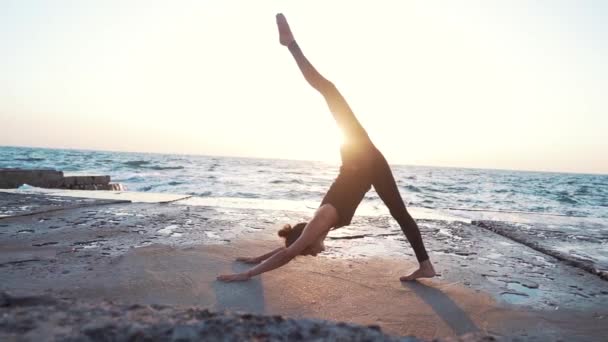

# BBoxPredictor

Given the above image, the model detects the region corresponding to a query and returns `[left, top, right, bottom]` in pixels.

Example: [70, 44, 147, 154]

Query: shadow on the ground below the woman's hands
[213, 262, 266, 314]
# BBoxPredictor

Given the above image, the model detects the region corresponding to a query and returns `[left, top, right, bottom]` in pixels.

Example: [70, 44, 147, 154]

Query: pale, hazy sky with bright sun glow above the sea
[0, 0, 608, 173]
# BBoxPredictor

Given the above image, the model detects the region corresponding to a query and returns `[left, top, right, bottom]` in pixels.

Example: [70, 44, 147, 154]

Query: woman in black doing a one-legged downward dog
[218, 14, 435, 281]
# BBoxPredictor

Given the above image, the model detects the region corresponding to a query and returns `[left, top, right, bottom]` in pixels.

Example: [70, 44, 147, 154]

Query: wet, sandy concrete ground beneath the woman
[0, 191, 608, 340]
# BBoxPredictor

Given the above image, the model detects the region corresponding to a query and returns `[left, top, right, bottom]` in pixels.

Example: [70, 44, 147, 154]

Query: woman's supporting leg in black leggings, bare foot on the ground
[372, 152, 435, 280]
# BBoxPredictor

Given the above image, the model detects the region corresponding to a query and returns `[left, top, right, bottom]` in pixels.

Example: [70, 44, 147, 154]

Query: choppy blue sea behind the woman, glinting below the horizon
[0, 146, 608, 270]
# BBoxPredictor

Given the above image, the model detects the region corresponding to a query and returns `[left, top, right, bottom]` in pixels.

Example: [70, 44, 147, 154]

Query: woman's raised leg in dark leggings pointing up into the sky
[277, 14, 369, 140]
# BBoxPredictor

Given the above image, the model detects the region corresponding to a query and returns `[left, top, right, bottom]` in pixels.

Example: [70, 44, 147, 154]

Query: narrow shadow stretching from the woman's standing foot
[402, 281, 479, 336]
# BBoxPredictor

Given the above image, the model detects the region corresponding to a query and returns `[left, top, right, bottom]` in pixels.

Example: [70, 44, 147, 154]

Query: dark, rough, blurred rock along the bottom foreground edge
[0, 293, 458, 342]
